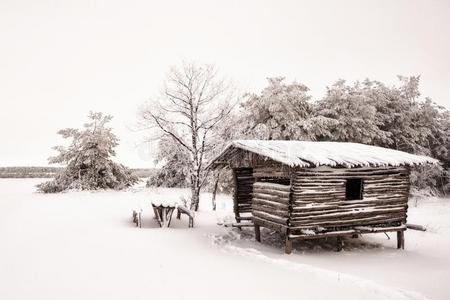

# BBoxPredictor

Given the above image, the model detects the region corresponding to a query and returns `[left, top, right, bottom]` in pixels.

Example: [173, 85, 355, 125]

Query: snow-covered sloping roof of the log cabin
[210, 140, 439, 168]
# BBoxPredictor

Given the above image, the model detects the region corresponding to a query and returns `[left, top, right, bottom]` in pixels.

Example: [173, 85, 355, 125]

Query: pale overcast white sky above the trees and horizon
[0, 0, 450, 167]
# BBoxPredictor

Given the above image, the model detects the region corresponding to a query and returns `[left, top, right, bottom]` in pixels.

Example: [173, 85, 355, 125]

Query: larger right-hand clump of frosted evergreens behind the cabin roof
[315, 76, 450, 192]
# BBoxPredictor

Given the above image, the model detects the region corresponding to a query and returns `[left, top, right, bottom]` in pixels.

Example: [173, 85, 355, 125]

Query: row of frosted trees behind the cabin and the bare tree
[149, 76, 450, 194]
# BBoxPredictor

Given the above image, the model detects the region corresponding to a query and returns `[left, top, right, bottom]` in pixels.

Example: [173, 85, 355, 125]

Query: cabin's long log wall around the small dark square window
[289, 167, 409, 234]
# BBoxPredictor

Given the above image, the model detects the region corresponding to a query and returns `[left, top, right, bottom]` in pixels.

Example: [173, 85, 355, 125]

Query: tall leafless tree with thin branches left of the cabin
[141, 63, 234, 210]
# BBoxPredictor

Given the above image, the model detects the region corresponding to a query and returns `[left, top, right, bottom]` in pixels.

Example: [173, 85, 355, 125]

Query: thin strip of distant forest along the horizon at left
[0, 167, 156, 178]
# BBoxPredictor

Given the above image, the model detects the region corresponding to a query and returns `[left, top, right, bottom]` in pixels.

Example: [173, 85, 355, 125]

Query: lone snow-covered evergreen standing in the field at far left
[38, 112, 139, 193]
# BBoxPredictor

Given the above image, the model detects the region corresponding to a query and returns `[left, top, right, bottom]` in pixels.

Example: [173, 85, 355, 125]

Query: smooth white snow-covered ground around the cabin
[0, 179, 450, 300]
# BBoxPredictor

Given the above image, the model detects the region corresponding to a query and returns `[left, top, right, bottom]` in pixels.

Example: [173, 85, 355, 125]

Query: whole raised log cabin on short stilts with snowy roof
[210, 140, 437, 253]
